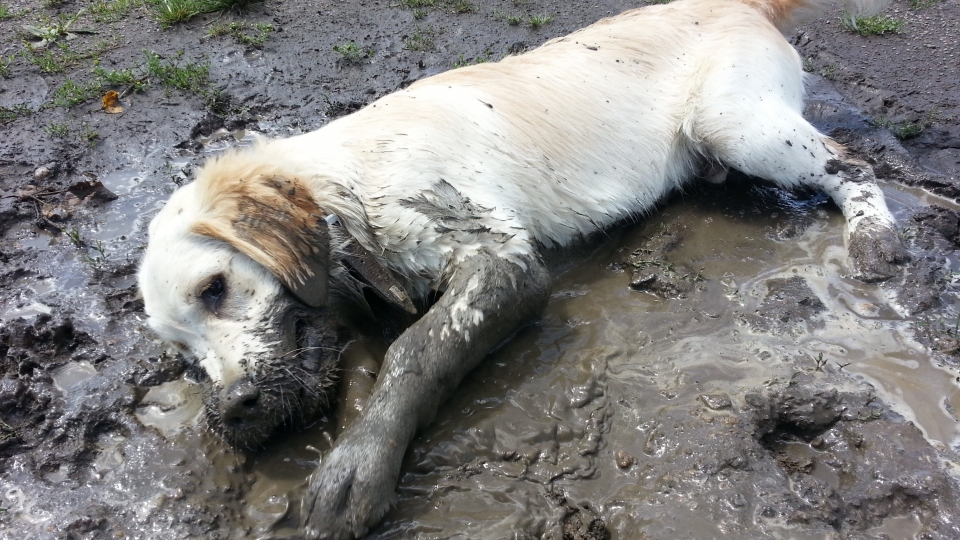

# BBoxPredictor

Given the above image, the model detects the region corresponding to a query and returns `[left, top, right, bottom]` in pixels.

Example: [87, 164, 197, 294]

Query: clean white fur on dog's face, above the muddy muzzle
[140, 200, 289, 386]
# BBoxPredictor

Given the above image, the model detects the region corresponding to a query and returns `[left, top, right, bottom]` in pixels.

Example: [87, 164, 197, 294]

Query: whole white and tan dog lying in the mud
[139, 0, 907, 539]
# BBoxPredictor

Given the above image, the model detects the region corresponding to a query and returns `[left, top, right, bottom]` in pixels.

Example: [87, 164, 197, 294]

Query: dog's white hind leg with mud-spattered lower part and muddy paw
[698, 107, 908, 282]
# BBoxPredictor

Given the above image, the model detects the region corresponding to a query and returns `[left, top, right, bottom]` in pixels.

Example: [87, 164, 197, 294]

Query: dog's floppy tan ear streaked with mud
[191, 176, 330, 307]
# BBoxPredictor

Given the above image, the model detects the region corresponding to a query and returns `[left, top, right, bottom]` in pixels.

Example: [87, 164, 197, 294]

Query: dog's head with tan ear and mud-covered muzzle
[138, 155, 338, 447]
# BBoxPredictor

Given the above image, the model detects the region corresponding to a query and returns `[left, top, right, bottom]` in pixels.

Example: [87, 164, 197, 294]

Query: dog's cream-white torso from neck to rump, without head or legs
[255, 0, 883, 292]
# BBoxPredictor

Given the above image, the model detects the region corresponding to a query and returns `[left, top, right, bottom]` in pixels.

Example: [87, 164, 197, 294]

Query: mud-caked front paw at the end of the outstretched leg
[301, 439, 403, 540]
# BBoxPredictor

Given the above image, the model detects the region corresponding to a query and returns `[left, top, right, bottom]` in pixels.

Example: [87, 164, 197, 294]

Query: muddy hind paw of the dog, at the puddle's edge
[847, 225, 910, 283]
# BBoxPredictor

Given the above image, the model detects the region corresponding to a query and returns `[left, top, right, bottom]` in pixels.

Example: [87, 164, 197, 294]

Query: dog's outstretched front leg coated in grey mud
[302, 251, 550, 539]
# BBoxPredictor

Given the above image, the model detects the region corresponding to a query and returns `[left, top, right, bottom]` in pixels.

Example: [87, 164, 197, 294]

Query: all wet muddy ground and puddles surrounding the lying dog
[0, 0, 960, 540]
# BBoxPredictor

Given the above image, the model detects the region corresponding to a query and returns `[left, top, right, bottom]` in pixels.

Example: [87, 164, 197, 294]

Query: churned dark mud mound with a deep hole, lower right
[745, 377, 957, 538]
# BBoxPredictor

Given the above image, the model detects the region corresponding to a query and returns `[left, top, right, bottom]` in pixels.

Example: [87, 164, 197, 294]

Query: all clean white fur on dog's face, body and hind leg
[140, 0, 893, 390]
